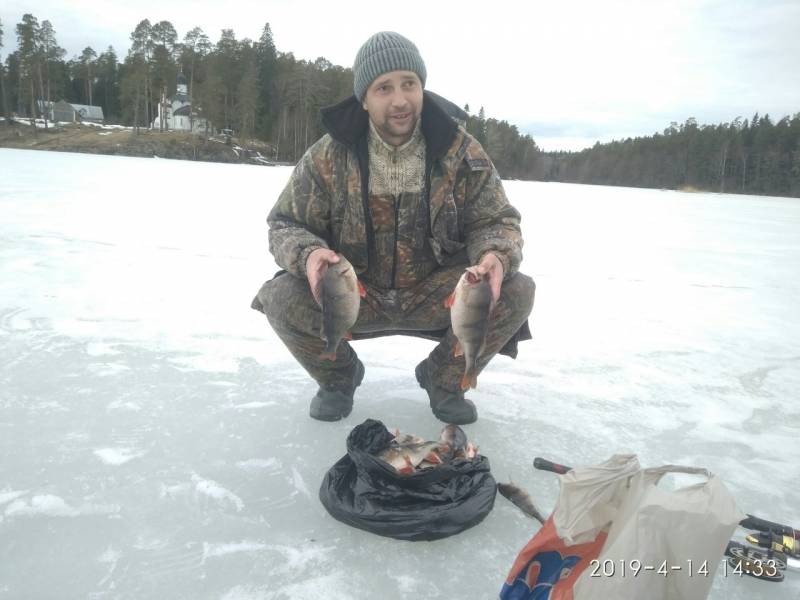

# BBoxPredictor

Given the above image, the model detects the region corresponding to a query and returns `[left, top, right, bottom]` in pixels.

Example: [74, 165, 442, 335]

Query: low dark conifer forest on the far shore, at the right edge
[535, 113, 800, 197]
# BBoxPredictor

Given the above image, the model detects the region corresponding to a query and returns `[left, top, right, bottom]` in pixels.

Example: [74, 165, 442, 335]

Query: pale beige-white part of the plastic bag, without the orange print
[553, 455, 744, 600]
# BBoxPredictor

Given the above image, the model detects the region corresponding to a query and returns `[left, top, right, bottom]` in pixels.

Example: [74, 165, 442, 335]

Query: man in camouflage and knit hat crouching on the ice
[253, 31, 535, 424]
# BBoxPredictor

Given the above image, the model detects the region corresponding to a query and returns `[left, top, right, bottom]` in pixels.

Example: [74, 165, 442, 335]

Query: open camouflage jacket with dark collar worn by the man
[267, 93, 522, 284]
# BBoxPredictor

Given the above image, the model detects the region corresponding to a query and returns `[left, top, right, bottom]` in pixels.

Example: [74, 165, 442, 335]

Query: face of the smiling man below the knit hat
[363, 71, 422, 146]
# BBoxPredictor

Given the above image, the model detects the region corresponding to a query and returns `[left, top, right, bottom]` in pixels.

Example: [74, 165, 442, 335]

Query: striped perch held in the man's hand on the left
[318, 254, 365, 360]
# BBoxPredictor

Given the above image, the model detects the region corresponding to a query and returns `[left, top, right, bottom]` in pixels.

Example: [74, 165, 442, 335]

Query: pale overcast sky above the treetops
[0, 0, 800, 150]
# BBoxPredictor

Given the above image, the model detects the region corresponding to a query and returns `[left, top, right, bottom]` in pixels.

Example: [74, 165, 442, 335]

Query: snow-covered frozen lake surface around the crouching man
[0, 149, 800, 600]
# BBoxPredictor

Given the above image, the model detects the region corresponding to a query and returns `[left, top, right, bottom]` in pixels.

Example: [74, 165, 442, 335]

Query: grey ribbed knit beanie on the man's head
[353, 31, 426, 101]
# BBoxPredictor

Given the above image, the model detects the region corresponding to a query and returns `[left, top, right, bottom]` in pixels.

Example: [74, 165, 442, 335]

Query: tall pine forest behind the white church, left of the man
[0, 14, 353, 160]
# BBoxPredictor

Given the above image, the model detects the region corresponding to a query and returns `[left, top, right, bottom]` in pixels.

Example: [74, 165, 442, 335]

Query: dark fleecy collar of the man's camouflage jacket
[320, 92, 458, 158]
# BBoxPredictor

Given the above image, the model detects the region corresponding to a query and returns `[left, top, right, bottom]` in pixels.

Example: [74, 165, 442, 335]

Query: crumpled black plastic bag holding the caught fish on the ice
[319, 419, 497, 541]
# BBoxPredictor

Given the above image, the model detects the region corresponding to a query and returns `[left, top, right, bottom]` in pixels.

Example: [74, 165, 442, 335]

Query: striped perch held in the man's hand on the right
[445, 267, 494, 390]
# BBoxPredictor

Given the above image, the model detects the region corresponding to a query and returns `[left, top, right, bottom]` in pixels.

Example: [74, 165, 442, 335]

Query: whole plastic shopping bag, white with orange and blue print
[500, 454, 744, 600]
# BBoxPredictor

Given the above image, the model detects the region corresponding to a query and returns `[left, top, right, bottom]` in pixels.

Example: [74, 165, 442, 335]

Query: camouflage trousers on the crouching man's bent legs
[253, 265, 536, 391]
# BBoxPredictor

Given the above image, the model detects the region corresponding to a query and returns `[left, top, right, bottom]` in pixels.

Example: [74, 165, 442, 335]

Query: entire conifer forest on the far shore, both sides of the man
[0, 14, 800, 196]
